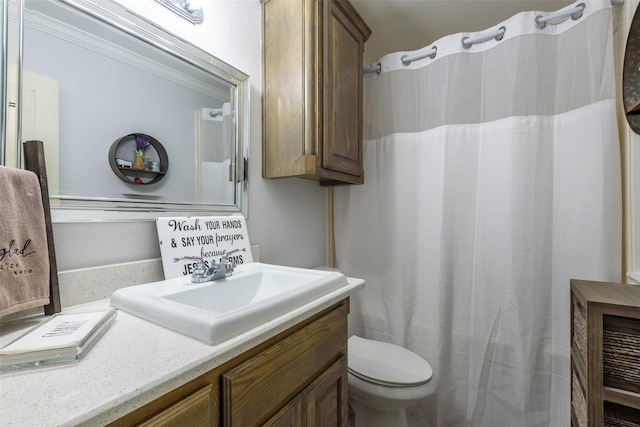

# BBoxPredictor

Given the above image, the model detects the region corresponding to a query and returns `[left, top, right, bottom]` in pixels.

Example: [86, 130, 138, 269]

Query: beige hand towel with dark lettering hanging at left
[0, 166, 49, 316]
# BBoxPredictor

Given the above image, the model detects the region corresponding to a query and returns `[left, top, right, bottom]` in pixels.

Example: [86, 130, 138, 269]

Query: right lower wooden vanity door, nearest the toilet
[302, 356, 349, 427]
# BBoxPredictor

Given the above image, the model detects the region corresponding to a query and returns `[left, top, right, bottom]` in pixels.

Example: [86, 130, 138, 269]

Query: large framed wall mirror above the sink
[5, 0, 249, 220]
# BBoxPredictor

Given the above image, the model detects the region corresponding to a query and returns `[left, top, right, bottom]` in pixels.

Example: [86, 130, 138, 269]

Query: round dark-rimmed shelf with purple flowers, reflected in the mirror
[109, 133, 169, 185]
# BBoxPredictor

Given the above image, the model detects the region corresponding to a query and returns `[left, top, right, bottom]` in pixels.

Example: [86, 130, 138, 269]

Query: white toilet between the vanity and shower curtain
[348, 335, 435, 427]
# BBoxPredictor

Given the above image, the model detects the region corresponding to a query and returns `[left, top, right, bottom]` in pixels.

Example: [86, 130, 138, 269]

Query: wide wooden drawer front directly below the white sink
[222, 304, 347, 426]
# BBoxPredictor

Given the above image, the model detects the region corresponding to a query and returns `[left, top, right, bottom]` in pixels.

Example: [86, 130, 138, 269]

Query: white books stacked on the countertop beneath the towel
[0, 308, 117, 371]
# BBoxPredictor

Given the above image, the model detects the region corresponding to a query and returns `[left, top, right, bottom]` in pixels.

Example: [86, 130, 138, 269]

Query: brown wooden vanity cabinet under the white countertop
[112, 300, 348, 427]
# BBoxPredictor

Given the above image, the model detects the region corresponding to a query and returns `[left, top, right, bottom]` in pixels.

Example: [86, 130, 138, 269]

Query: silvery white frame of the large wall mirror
[2, 0, 250, 222]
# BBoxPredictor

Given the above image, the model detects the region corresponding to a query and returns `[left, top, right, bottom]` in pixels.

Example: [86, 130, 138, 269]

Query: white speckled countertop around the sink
[0, 278, 364, 427]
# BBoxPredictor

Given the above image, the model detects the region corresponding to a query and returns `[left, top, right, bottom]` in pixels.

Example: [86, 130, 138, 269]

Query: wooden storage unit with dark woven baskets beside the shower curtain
[571, 280, 640, 427]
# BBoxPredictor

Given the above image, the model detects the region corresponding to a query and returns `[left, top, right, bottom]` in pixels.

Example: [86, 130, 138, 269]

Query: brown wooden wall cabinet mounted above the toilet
[262, 0, 371, 185]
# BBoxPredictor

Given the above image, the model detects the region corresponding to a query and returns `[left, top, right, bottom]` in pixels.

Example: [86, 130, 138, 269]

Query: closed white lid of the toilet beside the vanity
[348, 335, 433, 387]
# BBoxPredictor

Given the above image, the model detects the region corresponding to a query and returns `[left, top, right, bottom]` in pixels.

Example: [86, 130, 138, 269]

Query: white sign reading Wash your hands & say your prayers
[156, 215, 253, 279]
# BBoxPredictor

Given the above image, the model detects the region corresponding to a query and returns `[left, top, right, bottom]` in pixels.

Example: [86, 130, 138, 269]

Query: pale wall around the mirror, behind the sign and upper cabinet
[54, 0, 326, 271]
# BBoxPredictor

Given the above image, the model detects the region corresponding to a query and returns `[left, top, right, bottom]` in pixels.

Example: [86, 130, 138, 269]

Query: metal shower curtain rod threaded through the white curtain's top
[363, 0, 624, 75]
